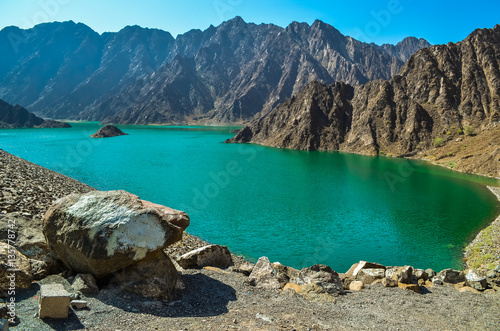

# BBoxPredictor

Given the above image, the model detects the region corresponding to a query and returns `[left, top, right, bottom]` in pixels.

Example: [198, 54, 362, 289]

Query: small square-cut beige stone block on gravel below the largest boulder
[38, 284, 70, 318]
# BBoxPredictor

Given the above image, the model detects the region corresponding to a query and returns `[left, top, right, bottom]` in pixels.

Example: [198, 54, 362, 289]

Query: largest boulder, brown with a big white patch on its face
[43, 191, 189, 278]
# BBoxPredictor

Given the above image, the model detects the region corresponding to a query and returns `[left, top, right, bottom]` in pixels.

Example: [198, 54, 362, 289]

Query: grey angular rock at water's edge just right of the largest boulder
[177, 245, 233, 269]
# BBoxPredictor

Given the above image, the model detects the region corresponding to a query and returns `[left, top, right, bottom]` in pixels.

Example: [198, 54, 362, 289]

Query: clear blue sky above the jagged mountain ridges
[0, 0, 500, 44]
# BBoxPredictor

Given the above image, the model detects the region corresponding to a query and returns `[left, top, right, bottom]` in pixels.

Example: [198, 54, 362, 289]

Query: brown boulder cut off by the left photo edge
[0, 242, 33, 292]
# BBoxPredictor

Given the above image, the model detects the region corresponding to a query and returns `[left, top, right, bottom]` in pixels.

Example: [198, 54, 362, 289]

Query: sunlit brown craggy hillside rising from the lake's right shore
[231, 25, 500, 176]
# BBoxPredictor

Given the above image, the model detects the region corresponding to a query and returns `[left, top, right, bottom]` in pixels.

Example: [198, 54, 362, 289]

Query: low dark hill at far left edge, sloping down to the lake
[0, 99, 70, 129]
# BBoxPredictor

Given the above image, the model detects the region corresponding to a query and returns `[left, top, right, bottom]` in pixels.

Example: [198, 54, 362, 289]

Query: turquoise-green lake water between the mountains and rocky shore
[0, 123, 498, 272]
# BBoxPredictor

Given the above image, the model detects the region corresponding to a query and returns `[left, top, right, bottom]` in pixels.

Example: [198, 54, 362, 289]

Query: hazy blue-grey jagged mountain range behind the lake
[0, 17, 430, 124]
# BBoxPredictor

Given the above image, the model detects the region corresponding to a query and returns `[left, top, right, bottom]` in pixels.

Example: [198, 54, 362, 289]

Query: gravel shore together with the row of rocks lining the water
[0, 150, 500, 330]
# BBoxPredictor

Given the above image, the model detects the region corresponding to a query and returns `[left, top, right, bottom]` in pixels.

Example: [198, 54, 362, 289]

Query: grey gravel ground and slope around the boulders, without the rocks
[0, 150, 500, 330]
